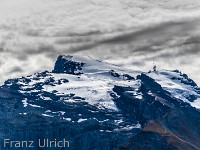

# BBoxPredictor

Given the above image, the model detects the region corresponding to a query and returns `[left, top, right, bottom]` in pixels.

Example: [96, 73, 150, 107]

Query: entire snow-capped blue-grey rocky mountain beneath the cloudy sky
[0, 56, 200, 150]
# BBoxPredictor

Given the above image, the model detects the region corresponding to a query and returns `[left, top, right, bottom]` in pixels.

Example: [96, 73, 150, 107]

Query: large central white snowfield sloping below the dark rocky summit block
[18, 56, 141, 111]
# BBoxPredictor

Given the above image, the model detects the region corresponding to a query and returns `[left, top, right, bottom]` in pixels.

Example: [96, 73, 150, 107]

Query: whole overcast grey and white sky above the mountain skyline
[0, 0, 200, 85]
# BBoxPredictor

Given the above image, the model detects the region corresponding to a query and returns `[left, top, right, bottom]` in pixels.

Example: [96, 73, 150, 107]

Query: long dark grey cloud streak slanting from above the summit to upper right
[63, 20, 199, 52]
